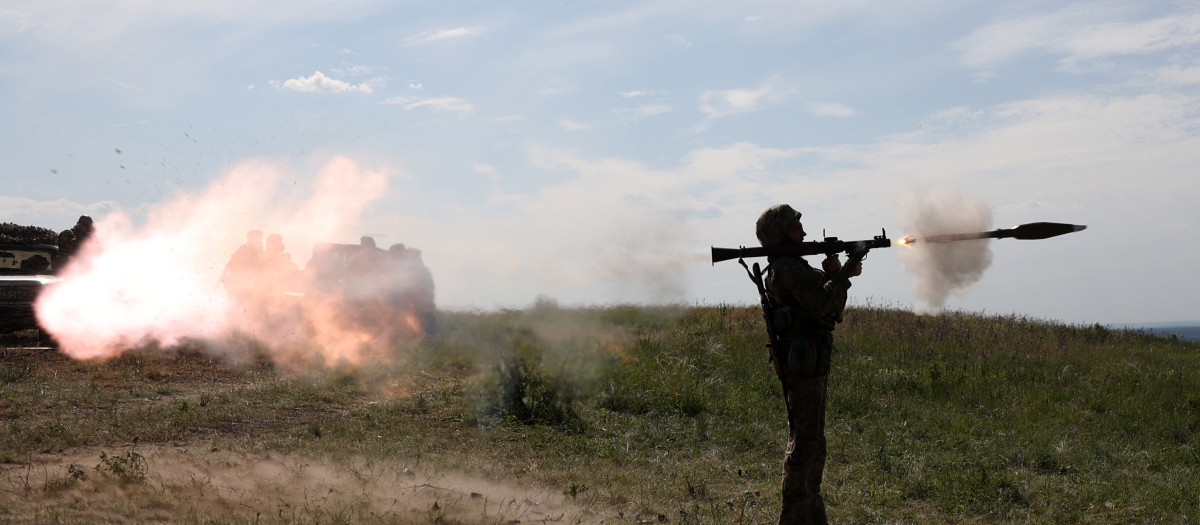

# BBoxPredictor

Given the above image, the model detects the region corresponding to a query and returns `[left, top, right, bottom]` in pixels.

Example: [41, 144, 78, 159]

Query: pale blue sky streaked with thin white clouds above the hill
[0, 0, 1200, 325]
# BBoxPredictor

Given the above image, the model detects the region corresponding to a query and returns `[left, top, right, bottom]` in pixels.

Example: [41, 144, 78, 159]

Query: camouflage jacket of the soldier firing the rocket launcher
[766, 257, 850, 338]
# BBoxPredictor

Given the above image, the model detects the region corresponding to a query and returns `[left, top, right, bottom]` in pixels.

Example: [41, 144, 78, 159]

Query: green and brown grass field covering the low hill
[0, 304, 1200, 524]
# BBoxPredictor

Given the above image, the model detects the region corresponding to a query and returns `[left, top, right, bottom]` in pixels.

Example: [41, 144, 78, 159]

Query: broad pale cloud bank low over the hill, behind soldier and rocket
[424, 91, 1200, 322]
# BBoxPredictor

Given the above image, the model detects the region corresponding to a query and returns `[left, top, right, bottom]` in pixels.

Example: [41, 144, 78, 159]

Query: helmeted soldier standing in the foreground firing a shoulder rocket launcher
[756, 204, 863, 525]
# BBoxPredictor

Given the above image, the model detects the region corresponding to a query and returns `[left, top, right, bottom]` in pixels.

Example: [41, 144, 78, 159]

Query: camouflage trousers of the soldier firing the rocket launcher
[779, 334, 833, 525]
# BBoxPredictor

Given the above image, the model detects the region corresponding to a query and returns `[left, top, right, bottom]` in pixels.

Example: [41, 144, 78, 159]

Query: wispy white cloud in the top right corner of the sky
[953, 4, 1200, 70]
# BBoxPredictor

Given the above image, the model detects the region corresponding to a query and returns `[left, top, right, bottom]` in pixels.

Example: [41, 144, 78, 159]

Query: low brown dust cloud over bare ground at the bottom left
[0, 446, 600, 524]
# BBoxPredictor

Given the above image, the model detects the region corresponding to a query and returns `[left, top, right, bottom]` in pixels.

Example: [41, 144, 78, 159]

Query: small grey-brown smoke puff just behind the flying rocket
[899, 187, 991, 314]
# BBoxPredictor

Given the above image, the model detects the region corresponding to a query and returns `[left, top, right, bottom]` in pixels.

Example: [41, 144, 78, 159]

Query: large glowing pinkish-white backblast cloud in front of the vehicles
[36, 157, 386, 362]
